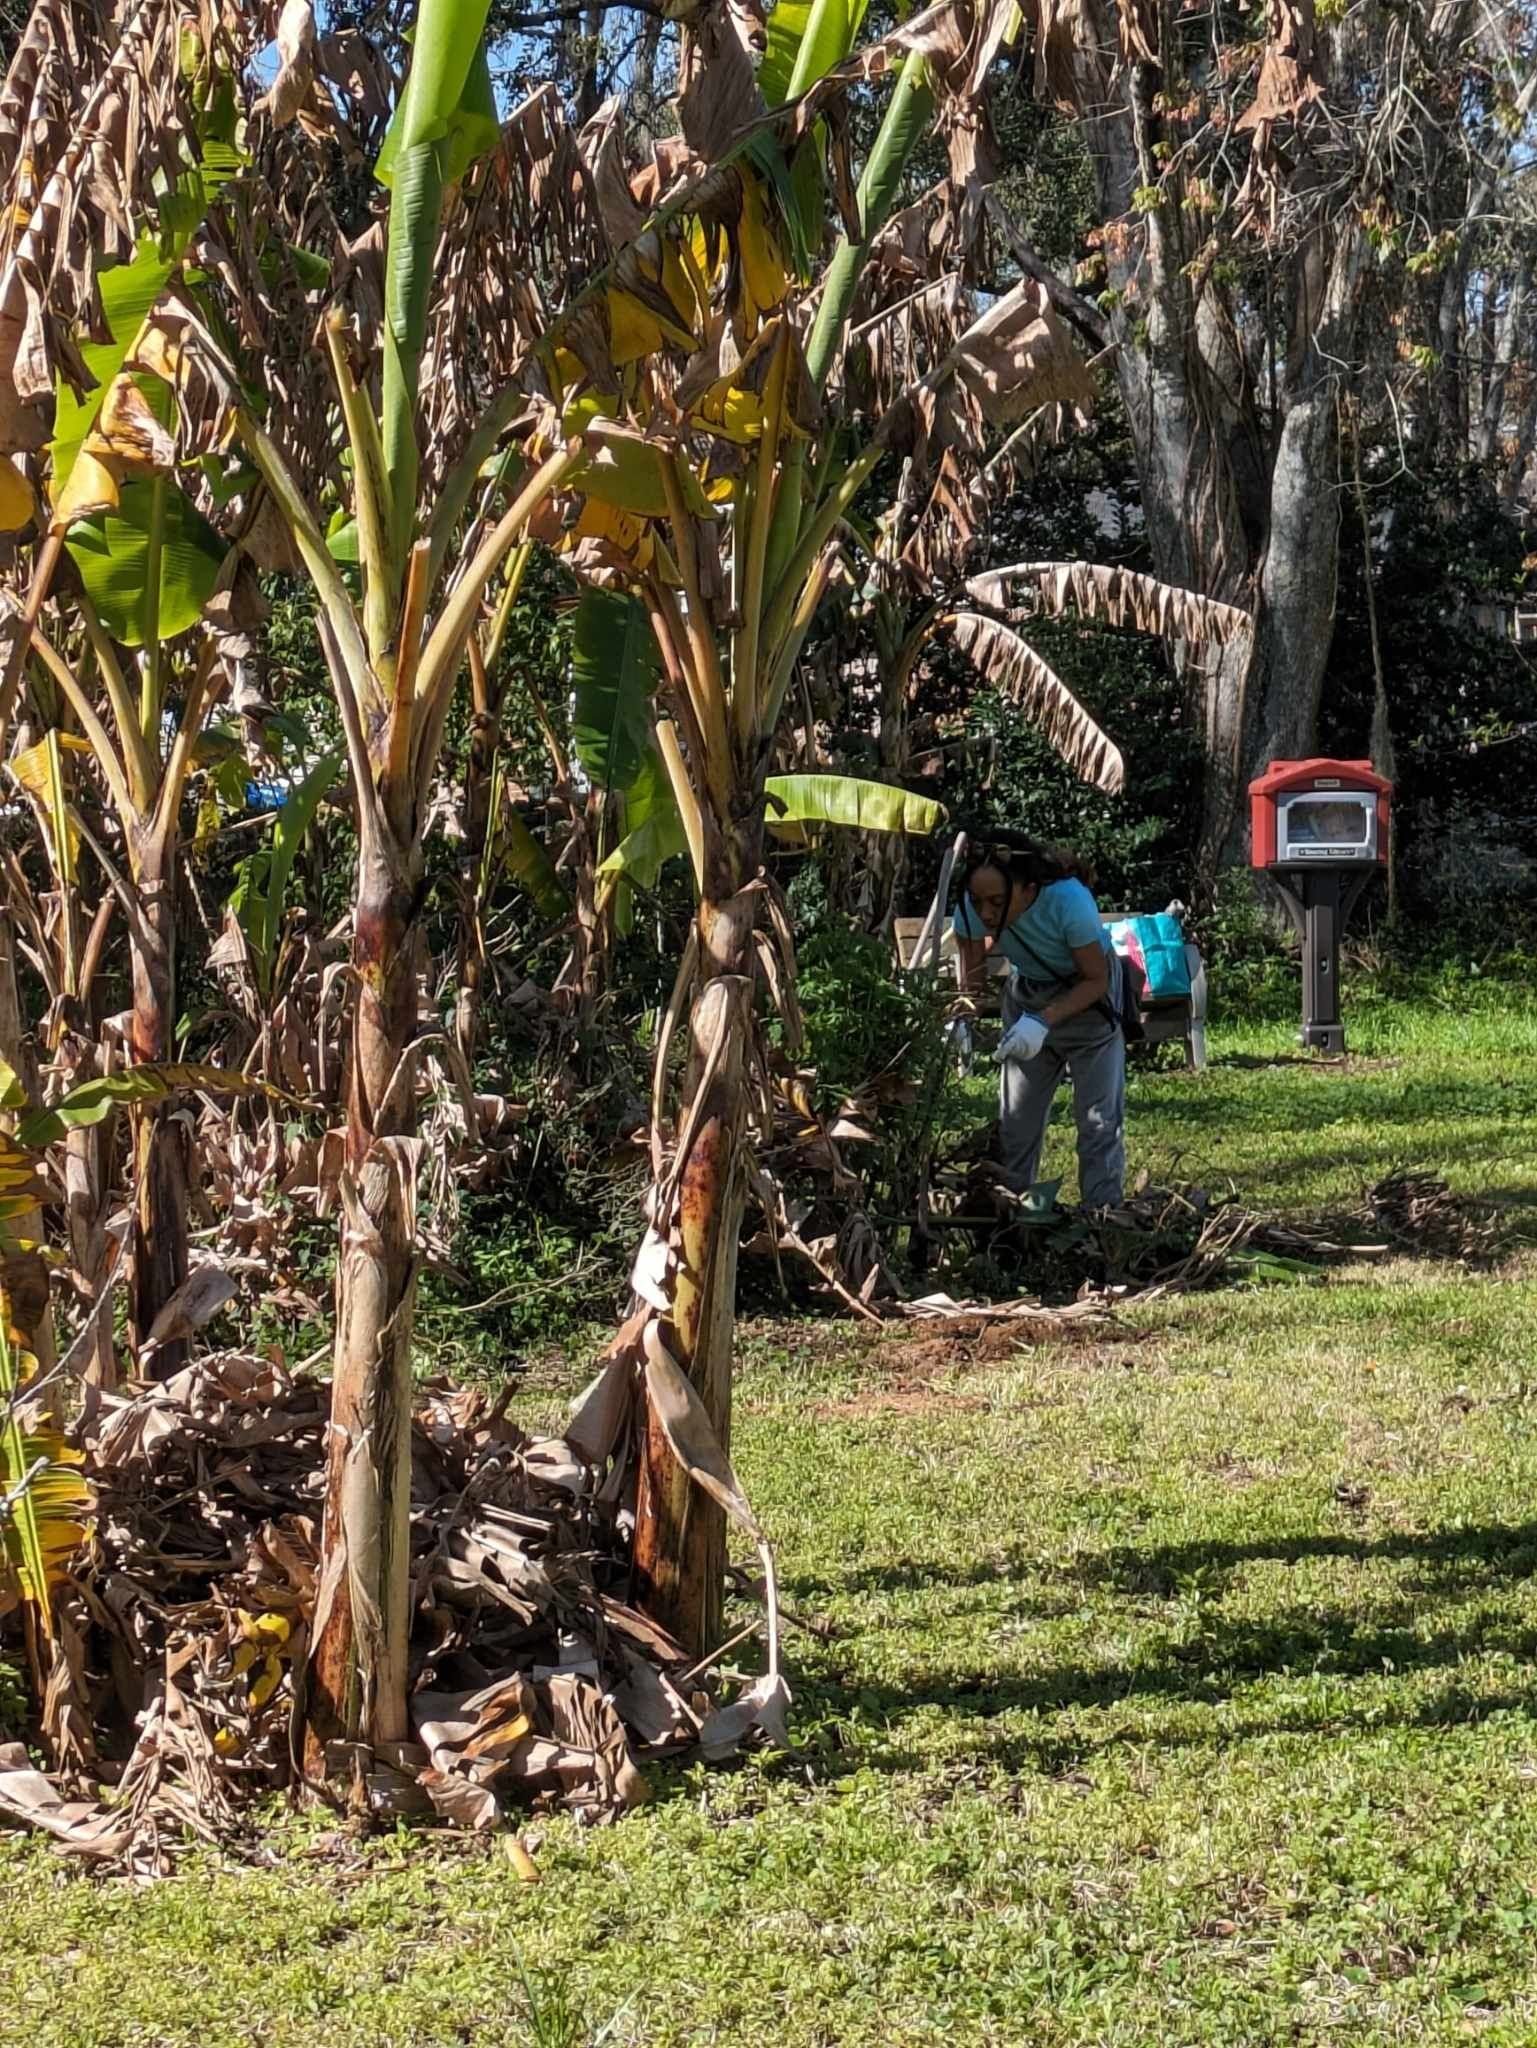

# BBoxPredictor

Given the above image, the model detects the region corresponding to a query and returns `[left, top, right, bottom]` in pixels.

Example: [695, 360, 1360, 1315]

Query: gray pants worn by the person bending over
[998, 961, 1125, 1208]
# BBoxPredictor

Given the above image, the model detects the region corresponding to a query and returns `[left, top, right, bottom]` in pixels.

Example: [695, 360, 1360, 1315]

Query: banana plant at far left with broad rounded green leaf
[0, 35, 259, 1374]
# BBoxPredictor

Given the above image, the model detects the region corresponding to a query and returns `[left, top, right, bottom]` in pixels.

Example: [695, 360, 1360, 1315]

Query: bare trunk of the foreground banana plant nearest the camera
[305, 817, 422, 1778]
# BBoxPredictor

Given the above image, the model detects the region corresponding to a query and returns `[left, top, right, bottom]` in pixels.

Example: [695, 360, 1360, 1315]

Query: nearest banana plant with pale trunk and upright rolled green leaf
[227, 0, 582, 1778]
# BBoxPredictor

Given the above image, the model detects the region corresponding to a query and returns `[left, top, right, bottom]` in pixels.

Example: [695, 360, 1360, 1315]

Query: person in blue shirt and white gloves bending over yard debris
[955, 842, 1125, 1208]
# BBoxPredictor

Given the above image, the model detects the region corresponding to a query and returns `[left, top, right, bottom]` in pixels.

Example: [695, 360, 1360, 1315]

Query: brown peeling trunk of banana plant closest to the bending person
[633, 842, 758, 1657]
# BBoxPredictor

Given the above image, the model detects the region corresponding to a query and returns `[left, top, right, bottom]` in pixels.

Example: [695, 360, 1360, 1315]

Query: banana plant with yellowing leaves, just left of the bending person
[483, 0, 1123, 1653]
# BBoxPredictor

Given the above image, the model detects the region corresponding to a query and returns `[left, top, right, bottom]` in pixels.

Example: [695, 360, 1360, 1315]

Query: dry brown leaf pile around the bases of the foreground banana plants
[0, 1352, 770, 1876]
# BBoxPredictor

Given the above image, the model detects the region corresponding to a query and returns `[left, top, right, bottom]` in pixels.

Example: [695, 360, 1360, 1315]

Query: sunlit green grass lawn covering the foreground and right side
[0, 991, 1537, 2048]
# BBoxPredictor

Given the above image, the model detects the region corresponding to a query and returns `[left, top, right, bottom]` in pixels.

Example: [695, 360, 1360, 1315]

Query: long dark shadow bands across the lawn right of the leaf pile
[770, 1522, 1537, 1776]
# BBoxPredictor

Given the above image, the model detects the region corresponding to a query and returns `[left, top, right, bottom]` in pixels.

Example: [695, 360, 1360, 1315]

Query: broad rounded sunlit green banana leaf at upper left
[68, 483, 225, 647]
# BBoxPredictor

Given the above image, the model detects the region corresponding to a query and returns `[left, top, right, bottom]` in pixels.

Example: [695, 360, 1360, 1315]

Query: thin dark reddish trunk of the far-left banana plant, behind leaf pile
[129, 834, 191, 1380]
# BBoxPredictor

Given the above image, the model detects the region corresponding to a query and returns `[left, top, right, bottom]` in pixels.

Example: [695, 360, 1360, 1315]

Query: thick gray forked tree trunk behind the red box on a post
[1072, 0, 1365, 883]
